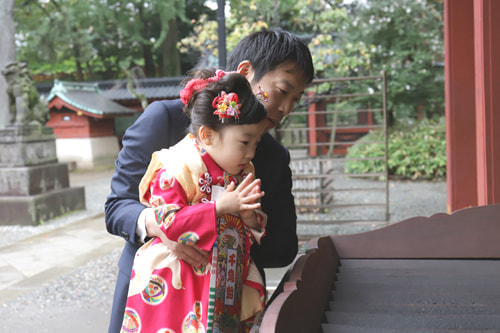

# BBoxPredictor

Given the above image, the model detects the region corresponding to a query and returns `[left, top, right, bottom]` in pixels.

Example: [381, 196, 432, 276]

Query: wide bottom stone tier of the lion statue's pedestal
[0, 187, 86, 225]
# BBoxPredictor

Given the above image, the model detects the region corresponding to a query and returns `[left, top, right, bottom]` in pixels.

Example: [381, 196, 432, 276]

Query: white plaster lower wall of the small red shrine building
[56, 136, 120, 169]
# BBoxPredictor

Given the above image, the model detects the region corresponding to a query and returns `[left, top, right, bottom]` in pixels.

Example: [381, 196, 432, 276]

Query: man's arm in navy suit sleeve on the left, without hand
[104, 100, 189, 245]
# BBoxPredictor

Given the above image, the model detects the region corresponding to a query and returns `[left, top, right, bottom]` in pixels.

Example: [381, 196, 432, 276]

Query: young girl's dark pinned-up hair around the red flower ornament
[184, 68, 267, 134]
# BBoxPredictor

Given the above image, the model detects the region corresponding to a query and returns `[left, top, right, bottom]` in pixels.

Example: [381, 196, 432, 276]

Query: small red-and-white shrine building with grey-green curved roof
[46, 80, 136, 169]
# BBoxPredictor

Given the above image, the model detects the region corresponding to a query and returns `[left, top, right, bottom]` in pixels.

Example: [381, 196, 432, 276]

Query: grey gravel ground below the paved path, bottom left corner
[0, 249, 121, 333]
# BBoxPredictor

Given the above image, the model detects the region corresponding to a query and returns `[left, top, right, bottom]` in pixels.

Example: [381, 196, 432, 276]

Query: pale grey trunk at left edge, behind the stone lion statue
[0, 0, 16, 128]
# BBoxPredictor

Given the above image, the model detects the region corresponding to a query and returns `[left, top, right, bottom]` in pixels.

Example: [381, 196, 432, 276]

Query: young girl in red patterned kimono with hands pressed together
[122, 70, 266, 333]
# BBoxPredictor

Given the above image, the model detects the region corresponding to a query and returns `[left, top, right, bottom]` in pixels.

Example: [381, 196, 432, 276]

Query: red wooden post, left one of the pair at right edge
[444, 0, 477, 212]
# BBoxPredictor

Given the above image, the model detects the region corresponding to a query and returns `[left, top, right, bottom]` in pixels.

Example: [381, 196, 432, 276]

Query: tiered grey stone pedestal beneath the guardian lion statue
[0, 124, 85, 225]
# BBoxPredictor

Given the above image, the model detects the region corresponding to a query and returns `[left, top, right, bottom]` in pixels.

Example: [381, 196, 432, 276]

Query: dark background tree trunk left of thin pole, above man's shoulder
[160, 18, 181, 76]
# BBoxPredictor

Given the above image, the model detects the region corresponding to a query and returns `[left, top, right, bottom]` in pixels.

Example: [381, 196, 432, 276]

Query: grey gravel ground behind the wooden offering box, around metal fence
[297, 178, 447, 239]
